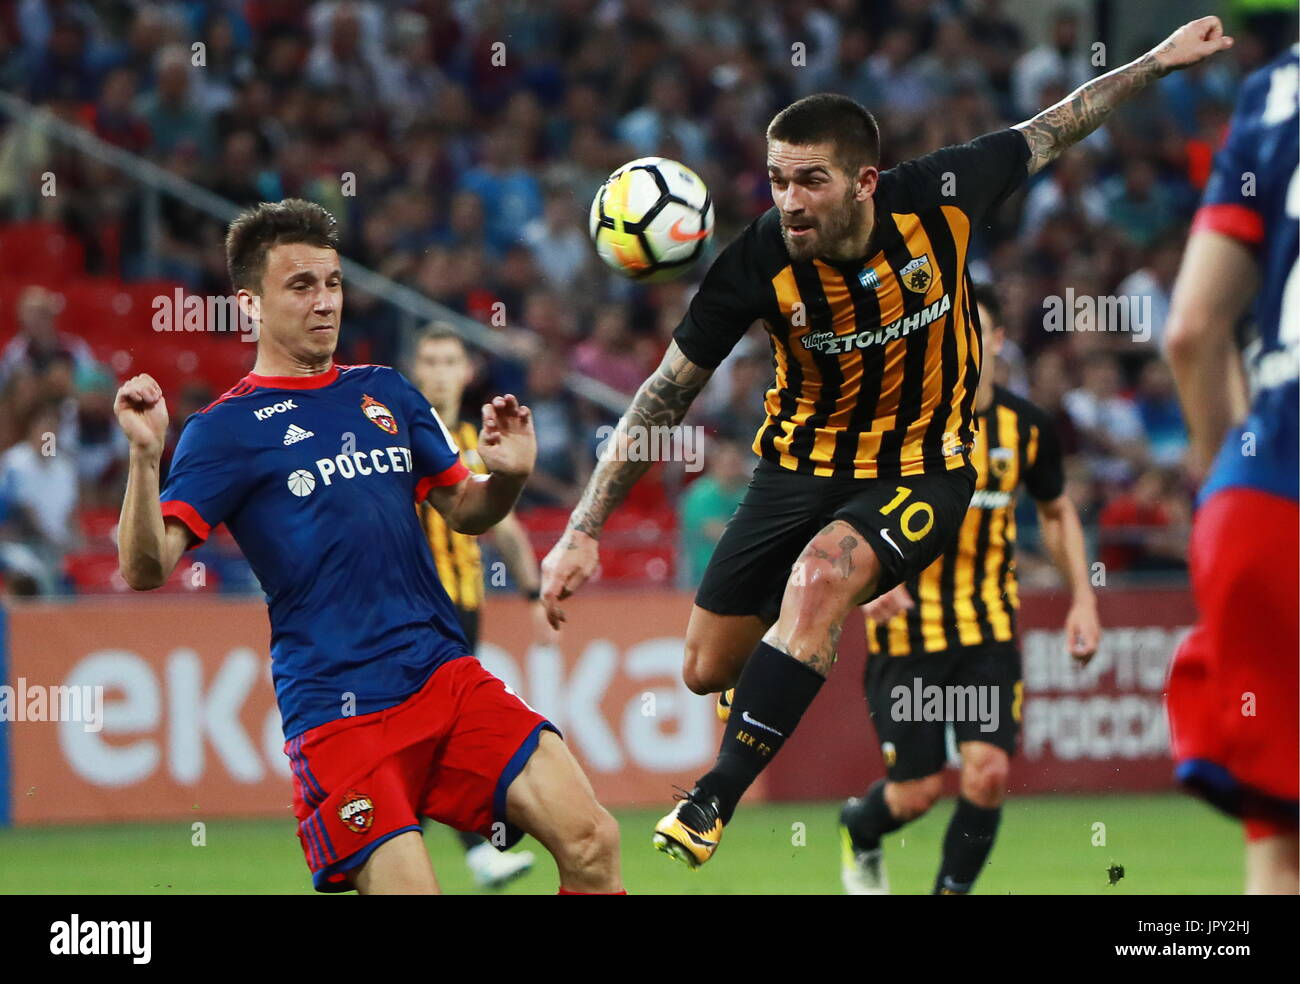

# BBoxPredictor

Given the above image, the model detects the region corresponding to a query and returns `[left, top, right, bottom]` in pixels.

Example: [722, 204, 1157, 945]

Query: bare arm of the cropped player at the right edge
[1165, 231, 1260, 476]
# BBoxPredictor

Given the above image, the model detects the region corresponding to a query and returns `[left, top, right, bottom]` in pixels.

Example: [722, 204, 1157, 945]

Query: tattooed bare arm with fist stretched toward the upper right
[1014, 17, 1232, 174]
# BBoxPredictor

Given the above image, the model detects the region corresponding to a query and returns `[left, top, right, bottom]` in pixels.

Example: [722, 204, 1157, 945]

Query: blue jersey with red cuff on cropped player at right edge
[1192, 45, 1300, 502]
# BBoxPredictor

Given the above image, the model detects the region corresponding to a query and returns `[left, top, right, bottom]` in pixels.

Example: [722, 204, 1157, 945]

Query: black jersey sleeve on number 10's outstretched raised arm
[888, 129, 1030, 226]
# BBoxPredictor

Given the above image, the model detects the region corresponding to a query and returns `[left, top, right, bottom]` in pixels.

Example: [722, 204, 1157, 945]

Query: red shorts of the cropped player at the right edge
[1166, 489, 1300, 827]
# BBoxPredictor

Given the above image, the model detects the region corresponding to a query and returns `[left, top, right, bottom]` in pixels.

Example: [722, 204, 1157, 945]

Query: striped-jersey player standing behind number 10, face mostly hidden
[840, 286, 1100, 896]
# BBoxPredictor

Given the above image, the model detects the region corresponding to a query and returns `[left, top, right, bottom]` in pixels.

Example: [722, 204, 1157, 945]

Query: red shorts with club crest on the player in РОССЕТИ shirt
[285, 656, 559, 892]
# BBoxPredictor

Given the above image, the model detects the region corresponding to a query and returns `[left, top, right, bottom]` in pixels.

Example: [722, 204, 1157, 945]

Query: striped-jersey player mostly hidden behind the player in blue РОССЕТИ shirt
[411, 324, 558, 888]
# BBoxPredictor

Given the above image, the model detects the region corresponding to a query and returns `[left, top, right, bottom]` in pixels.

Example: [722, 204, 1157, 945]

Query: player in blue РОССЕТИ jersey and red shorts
[116, 200, 623, 894]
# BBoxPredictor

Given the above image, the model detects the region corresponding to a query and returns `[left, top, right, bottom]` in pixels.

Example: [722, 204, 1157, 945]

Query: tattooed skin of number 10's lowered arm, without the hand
[568, 342, 712, 537]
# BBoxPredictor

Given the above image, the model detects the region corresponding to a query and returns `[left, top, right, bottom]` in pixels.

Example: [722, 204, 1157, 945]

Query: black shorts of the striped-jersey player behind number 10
[866, 642, 1024, 783]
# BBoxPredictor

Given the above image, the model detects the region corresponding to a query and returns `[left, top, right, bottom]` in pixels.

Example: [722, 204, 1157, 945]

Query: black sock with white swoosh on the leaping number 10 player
[696, 642, 826, 823]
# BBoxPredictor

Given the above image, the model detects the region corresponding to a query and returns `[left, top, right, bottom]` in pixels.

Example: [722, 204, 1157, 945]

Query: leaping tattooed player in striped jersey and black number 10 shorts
[542, 17, 1231, 866]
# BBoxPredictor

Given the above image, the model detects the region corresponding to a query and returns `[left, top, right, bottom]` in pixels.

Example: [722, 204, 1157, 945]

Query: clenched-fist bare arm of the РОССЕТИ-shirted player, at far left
[113, 374, 190, 591]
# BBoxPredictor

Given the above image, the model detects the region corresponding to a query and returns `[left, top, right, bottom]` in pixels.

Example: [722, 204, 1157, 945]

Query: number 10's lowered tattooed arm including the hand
[542, 342, 714, 628]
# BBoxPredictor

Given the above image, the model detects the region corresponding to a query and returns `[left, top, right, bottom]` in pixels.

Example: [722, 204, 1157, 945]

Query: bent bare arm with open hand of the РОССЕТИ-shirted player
[429, 394, 537, 537]
